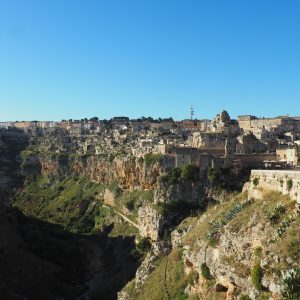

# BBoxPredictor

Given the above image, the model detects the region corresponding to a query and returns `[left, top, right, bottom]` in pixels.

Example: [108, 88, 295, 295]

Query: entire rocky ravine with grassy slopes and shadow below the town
[0, 127, 300, 300]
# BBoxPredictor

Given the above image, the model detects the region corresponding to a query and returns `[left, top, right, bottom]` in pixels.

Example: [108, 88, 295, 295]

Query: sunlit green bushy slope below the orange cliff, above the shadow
[13, 177, 104, 233]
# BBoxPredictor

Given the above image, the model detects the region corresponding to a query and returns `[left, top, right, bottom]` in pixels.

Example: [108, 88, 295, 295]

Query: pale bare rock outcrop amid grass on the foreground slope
[180, 197, 299, 300]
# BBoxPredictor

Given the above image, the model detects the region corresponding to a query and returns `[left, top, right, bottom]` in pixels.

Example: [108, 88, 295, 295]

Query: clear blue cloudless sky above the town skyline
[0, 0, 300, 120]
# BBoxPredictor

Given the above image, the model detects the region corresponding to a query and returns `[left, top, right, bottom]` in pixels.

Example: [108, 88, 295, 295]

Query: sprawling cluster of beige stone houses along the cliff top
[0, 111, 300, 171]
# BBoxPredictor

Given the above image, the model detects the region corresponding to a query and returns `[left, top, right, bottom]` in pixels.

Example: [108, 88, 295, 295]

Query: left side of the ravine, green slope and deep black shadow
[0, 130, 141, 299]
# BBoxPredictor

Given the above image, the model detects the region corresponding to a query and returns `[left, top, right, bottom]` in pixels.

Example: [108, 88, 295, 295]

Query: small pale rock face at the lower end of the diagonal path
[138, 205, 165, 241]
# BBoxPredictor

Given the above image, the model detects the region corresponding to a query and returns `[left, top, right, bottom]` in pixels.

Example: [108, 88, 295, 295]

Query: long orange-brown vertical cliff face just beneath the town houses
[27, 154, 164, 190]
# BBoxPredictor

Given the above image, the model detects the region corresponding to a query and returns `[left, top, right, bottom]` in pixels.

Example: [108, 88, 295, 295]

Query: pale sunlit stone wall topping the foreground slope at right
[244, 170, 300, 203]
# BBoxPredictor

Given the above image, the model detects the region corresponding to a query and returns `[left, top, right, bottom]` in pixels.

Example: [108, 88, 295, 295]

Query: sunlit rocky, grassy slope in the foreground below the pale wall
[119, 192, 300, 300]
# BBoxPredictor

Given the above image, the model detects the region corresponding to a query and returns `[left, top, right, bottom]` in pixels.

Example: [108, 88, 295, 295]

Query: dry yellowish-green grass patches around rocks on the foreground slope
[181, 192, 300, 292]
